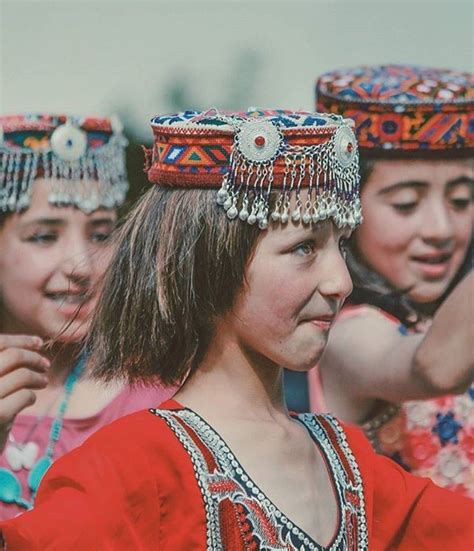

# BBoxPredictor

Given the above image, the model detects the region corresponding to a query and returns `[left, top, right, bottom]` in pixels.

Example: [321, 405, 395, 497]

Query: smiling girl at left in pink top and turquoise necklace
[0, 115, 172, 519]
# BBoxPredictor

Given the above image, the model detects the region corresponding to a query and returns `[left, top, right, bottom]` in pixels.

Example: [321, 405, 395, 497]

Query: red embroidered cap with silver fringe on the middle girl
[148, 109, 361, 229]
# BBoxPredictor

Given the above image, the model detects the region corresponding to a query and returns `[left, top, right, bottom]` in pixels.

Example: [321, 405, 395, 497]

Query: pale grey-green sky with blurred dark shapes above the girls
[0, 0, 474, 142]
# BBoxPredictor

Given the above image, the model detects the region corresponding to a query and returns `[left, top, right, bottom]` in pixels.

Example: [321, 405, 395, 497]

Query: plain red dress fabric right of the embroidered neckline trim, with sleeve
[344, 420, 474, 551]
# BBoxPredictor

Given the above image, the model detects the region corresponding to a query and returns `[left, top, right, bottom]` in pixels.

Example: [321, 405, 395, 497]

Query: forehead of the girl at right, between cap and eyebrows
[363, 158, 474, 191]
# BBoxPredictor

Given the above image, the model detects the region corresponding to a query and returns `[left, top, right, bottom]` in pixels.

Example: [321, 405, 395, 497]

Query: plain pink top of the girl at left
[0, 386, 175, 520]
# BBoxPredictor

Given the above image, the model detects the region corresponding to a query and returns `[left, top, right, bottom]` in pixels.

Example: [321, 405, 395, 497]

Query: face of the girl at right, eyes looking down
[355, 160, 474, 303]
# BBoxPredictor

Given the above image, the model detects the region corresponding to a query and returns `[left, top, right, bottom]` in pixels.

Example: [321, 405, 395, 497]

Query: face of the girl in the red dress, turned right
[226, 221, 352, 371]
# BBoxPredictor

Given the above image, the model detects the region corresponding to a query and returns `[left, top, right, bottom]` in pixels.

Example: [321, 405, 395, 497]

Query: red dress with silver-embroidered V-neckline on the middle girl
[0, 400, 474, 551]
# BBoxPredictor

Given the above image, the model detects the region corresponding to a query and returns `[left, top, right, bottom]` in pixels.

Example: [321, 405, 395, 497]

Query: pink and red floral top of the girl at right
[308, 305, 474, 498]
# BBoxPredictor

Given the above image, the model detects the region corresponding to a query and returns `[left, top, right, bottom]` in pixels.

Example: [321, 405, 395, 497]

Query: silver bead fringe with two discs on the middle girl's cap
[217, 121, 362, 229]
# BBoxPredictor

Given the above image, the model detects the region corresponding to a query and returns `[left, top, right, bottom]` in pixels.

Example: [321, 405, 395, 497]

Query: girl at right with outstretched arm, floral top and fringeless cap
[309, 66, 474, 497]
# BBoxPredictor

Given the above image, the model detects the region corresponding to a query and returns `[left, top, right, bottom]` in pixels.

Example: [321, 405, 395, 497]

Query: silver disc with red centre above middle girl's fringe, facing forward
[236, 120, 283, 163]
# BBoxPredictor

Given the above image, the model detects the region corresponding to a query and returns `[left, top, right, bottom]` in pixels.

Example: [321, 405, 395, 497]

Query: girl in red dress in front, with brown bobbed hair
[1, 111, 470, 551]
